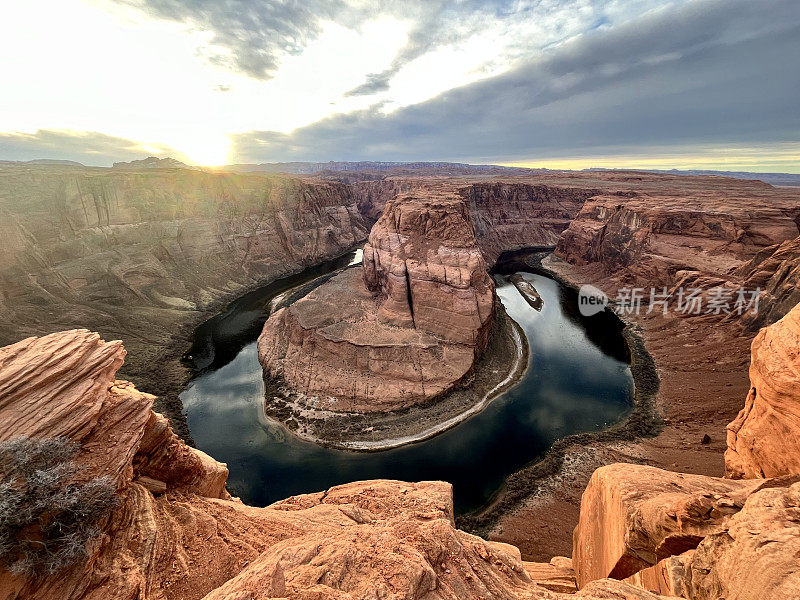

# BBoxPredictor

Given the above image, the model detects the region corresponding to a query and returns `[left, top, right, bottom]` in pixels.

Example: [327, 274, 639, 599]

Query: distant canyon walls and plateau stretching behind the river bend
[0, 159, 800, 434]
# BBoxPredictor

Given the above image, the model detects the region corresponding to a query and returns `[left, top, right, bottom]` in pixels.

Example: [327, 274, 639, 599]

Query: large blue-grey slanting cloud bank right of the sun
[234, 0, 800, 162]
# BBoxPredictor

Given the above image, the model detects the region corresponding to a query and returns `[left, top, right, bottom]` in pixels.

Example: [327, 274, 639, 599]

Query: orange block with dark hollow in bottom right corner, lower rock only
[573, 464, 800, 600]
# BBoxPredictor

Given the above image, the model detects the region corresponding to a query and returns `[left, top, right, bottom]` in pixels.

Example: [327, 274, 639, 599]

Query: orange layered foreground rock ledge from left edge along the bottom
[0, 330, 676, 600]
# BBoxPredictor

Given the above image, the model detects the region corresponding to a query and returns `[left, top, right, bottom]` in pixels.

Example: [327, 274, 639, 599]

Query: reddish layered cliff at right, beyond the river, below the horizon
[556, 174, 800, 287]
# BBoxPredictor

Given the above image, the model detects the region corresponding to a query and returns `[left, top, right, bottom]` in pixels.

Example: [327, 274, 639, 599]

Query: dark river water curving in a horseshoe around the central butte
[181, 254, 633, 513]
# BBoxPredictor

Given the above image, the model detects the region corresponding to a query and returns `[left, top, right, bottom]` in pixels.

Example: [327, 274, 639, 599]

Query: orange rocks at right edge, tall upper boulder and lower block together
[572, 305, 800, 600]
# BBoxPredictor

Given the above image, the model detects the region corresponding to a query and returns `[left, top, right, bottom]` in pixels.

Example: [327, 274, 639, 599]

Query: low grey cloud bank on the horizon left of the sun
[0, 129, 180, 166]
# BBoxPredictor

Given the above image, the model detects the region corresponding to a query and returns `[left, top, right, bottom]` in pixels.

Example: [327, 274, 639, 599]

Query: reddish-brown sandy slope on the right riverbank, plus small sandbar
[483, 263, 755, 561]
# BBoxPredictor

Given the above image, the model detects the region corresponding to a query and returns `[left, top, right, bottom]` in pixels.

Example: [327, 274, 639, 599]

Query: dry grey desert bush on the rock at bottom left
[0, 436, 115, 575]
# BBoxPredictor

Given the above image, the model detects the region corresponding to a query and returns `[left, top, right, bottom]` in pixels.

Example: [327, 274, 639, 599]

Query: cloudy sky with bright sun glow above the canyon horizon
[0, 0, 800, 172]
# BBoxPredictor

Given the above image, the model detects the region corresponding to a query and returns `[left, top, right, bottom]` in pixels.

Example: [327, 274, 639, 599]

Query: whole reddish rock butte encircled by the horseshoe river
[258, 196, 496, 412]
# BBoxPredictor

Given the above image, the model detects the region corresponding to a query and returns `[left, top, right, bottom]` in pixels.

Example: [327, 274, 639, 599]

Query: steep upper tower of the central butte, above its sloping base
[364, 196, 495, 346]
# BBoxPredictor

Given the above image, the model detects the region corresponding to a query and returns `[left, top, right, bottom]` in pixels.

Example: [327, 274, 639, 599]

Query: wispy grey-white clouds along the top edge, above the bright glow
[116, 0, 686, 87]
